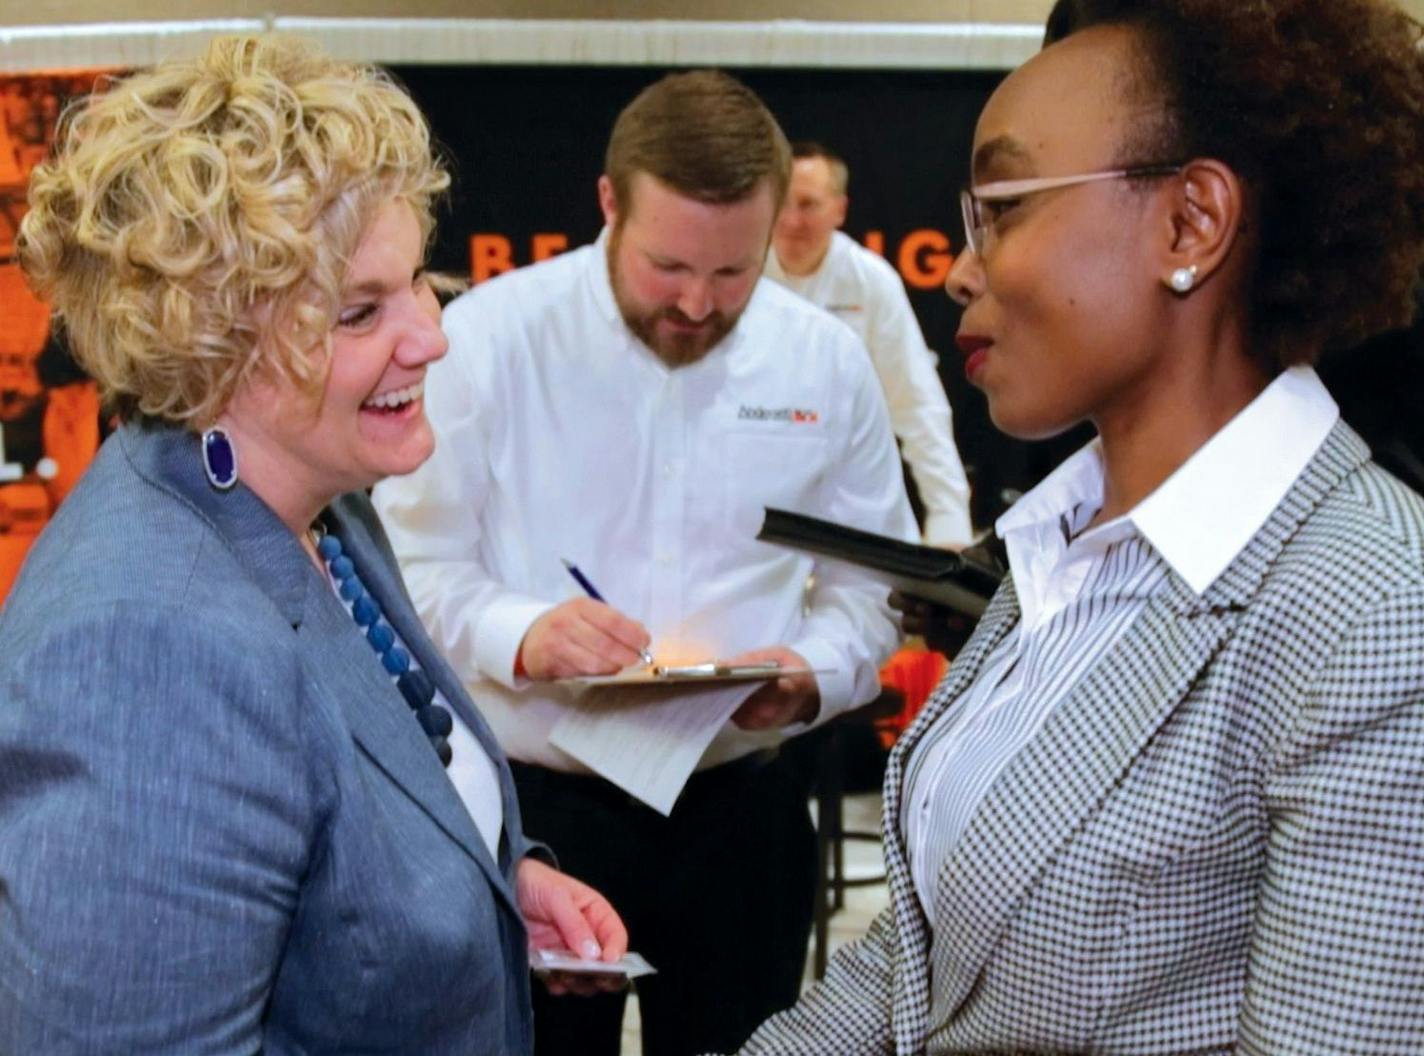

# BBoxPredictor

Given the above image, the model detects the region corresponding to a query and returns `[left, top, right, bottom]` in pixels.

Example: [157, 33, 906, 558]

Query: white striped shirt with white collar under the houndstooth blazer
[901, 367, 1340, 925]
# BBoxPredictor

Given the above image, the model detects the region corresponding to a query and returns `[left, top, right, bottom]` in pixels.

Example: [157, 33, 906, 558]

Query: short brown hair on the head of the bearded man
[604, 70, 792, 209]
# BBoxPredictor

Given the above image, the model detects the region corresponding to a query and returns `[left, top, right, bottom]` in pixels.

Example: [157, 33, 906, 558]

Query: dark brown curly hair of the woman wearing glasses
[1045, 0, 1424, 373]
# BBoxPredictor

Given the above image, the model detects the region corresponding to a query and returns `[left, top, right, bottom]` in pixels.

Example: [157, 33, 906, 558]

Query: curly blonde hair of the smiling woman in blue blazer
[19, 36, 450, 427]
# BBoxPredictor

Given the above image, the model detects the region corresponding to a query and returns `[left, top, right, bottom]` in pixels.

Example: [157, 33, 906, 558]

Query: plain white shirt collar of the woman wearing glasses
[995, 367, 1340, 593]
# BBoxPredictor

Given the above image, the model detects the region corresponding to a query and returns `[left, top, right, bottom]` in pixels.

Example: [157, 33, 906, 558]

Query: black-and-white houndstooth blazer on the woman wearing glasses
[743, 424, 1424, 1056]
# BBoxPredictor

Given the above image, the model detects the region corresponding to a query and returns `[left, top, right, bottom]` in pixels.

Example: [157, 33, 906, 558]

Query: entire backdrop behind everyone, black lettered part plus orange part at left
[0, 65, 1424, 599]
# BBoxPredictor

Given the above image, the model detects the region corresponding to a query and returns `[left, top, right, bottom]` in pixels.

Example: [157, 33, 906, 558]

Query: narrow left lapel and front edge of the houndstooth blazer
[881, 578, 1018, 1053]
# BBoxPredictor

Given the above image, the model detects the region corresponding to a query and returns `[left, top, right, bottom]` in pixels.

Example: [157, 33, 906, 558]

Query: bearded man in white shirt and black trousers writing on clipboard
[376, 71, 916, 1056]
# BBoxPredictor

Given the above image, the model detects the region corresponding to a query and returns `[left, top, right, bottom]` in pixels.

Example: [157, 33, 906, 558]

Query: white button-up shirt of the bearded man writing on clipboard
[375, 238, 914, 771]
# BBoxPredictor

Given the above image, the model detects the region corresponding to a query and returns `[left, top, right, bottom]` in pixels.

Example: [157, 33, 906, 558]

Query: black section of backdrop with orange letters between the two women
[394, 67, 1089, 525]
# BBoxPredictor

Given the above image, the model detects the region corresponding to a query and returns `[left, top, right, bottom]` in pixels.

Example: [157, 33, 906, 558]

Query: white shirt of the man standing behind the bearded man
[766, 231, 974, 547]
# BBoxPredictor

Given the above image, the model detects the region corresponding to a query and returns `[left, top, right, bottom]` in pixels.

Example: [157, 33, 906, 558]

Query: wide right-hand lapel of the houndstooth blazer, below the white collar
[917, 423, 1368, 1028]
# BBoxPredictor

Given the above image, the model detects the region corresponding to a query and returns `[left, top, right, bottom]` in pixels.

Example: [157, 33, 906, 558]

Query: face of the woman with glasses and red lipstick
[947, 27, 1172, 438]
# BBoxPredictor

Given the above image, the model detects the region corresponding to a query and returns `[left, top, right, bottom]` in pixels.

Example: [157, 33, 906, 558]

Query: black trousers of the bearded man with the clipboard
[513, 757, 816, 1056]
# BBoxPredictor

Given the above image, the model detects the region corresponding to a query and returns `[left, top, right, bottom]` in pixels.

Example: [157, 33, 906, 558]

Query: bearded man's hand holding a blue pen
[514, 598, 651, 682]
